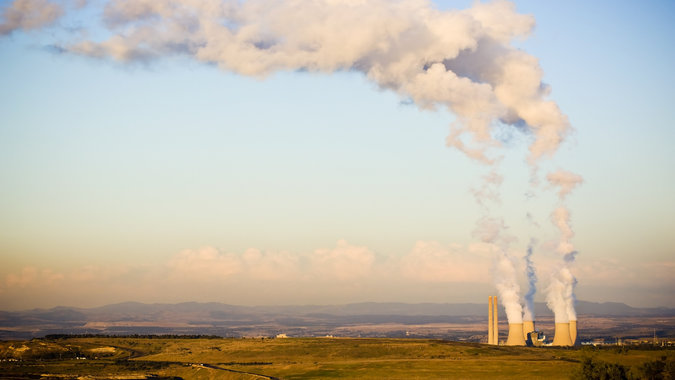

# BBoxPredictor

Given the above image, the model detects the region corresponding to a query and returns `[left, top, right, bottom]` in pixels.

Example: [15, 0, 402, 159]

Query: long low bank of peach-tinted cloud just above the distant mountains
[0, 240, 675, 308]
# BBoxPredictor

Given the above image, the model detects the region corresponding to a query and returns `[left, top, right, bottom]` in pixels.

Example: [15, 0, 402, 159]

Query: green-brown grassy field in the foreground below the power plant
[0, 337, 675, 379]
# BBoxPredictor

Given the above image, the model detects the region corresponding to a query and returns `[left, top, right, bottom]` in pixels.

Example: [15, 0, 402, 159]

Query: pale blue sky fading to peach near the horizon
[0, 0, 675, 310]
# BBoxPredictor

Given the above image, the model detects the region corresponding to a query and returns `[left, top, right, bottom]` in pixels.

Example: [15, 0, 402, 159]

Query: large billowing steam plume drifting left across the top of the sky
[1, 0, 570, 163]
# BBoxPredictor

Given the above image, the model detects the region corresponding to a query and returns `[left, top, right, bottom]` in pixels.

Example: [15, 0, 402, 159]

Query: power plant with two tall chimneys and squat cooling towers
[488, 296, 579, 347]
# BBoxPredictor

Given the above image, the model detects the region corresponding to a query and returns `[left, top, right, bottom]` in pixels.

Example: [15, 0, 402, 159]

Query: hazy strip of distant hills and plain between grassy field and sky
[0, 301, 675, 343]
